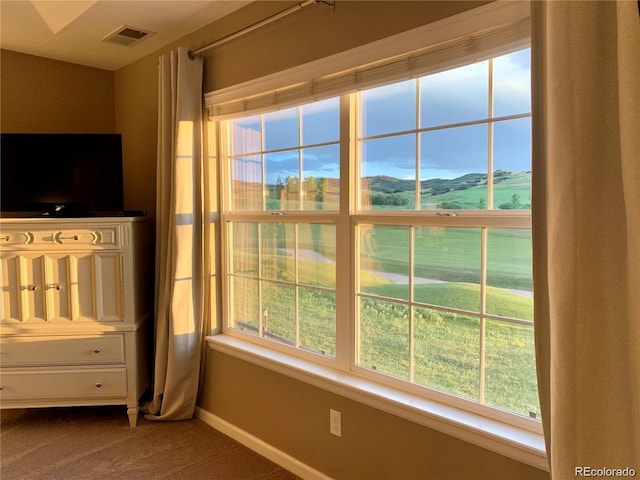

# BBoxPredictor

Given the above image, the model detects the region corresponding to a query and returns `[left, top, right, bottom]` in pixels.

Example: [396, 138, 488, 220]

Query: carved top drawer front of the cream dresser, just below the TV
[0, 225, 122, 250]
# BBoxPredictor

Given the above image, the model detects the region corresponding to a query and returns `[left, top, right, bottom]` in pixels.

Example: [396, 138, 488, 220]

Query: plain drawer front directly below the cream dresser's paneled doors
[0, 334, 124, 367]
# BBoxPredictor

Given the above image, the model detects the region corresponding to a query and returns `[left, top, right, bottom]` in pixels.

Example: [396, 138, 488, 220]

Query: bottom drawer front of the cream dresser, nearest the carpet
[0, 367, 127, 405]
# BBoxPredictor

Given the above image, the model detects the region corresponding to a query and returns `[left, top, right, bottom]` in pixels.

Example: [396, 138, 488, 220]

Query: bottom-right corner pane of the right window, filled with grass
[485, 320, 540, 418]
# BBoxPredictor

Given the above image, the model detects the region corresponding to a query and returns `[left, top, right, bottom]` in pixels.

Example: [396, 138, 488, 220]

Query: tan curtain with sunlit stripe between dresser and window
[147, 48, 204, 420]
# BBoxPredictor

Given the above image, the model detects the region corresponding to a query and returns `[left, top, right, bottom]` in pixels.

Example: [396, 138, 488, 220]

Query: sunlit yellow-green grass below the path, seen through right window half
[360, 283, 540, 416]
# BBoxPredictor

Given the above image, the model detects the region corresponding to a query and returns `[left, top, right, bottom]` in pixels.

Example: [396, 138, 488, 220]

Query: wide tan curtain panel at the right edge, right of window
[531, 1, 640, 479]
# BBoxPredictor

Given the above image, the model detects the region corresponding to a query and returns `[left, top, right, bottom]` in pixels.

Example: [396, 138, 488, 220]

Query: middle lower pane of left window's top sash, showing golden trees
[265, 150, 300, 210]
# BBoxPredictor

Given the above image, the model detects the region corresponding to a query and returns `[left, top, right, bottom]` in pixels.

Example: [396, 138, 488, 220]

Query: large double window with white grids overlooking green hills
[220, 49, 540, 424]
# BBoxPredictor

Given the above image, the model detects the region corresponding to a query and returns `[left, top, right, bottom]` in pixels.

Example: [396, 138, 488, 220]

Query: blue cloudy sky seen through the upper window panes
[230, 49, 531, 183]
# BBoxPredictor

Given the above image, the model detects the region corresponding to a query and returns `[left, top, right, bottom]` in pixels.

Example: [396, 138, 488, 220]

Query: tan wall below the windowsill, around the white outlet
[200, 350, 549, 480]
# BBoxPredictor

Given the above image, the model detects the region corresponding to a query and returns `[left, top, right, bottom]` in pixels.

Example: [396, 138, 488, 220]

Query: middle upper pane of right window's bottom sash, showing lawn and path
[413, 227, 481, 312]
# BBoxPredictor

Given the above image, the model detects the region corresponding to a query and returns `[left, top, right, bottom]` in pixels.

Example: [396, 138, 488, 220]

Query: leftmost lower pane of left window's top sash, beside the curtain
[231, 155, 263, 210]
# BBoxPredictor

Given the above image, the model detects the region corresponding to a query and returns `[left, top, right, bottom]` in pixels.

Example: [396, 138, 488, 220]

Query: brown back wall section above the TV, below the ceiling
[0, 50, 115, 133]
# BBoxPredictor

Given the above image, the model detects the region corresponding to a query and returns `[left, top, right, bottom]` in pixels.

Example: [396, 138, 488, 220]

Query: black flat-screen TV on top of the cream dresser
[0, 133, 124, 216]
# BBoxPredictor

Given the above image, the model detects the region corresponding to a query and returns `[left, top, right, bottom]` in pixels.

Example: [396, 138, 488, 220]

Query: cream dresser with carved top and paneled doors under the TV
[0, 217, 154, 426]
